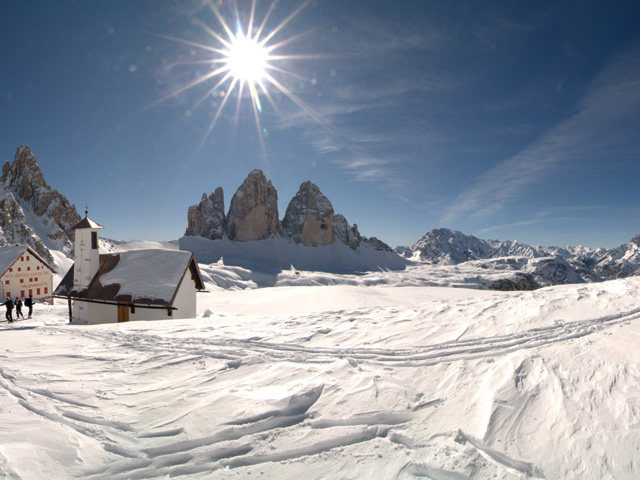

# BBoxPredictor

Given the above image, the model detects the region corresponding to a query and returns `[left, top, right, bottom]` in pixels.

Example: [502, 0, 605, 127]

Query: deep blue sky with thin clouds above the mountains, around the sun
[0, 0, 640, 246]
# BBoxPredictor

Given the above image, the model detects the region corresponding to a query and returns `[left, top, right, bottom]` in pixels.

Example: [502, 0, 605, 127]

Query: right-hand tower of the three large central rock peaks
[282, 181, 334, 246]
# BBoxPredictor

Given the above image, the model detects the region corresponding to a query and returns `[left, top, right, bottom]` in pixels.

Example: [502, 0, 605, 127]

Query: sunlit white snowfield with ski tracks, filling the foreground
[0, 276, 640, 480]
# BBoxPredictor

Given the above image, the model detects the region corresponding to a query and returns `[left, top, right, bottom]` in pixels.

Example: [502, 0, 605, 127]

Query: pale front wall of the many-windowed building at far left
[0, 251, 53, 300]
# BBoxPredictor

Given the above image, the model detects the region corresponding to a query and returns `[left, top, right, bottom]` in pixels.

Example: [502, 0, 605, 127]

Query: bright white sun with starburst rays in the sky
[152, 0, 324, 155]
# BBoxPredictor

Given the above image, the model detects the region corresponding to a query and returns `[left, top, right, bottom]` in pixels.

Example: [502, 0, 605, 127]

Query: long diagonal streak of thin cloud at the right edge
[442, 47, 640, 225]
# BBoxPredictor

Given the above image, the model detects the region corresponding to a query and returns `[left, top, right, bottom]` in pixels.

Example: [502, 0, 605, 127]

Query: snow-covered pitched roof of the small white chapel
[54, 249, 204, 306]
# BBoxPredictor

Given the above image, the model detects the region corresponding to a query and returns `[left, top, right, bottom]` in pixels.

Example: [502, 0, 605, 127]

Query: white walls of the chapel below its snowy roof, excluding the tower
[73, 271, 196, 325]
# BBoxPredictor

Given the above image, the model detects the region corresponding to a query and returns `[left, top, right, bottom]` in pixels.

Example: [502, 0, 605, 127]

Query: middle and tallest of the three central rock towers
[227, 170, 280, 242]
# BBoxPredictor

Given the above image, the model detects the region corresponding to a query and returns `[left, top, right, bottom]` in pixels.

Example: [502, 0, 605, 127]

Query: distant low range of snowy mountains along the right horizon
[395, 228, 640, 285]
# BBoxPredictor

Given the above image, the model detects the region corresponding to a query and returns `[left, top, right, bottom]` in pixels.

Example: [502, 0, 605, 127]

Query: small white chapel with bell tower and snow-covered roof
[54, 216, 204, 324]
